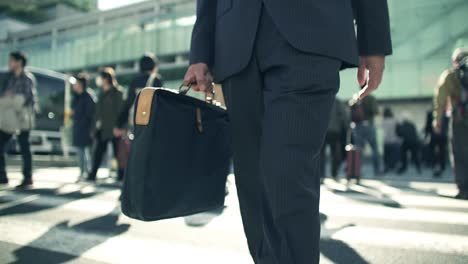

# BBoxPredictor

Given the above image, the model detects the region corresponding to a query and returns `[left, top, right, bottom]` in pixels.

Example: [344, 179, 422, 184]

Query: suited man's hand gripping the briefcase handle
[184, 63, 213, 93]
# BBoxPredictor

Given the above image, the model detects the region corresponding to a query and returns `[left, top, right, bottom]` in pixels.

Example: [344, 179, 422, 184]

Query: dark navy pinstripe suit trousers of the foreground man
[223, 5, 341, 264]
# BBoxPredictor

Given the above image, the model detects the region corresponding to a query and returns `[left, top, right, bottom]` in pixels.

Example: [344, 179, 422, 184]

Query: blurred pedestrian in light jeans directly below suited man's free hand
[351, 87, 382, 176]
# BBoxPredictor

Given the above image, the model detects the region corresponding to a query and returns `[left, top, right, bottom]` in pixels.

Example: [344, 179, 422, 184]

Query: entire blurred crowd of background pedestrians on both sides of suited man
[0, 49, 468, 199]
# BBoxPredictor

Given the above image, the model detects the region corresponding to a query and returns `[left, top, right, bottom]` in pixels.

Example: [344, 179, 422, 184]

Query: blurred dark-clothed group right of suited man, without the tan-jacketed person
[321, 95, 449, 179]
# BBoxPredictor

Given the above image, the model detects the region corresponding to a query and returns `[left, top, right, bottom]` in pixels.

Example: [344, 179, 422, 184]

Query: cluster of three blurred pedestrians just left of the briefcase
[68, 53, 162, 182]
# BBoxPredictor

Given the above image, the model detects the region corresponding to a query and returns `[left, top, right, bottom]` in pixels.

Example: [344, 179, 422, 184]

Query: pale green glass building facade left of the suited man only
[0, 1, 195, 71]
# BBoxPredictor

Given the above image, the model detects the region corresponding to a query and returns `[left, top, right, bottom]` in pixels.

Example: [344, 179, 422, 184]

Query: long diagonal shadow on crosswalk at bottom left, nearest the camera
[13, 207, 130, 264]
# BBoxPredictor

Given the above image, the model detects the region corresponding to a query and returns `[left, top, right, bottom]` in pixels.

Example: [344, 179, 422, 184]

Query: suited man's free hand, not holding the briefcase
[357, 55, 385, 99]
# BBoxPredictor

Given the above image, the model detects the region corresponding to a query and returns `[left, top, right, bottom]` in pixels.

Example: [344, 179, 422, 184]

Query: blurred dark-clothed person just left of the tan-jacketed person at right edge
[424, 109, 450, 177]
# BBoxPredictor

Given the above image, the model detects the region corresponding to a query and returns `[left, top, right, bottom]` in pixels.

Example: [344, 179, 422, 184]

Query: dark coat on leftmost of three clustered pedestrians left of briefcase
[72, 91, 96, 147]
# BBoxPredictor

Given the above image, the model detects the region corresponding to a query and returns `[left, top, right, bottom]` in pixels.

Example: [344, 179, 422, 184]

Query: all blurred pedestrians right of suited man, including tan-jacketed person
[321, 49, 468, 199]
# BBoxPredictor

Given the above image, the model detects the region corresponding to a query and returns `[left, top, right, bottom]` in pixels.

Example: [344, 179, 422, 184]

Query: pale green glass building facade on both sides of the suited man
[0, 0, 468, 99]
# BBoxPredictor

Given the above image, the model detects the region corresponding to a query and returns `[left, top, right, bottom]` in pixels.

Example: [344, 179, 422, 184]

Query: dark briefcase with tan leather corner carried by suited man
[122, 88, 231, 221]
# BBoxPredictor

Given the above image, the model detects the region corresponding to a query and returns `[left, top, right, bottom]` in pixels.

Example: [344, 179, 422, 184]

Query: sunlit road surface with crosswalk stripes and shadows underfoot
[0, 167, 468, 264]
